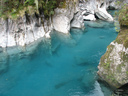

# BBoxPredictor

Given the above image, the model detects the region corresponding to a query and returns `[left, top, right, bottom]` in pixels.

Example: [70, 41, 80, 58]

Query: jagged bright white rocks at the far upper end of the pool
[80, 0, 113, 21]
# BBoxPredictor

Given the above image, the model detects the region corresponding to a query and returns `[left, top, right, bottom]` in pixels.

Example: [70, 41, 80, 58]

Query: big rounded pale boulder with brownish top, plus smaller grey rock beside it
[53, 0, 83, 33]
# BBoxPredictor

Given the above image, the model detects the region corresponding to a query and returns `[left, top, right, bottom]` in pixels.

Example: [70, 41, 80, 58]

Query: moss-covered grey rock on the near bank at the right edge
[98, 4, 128, 88]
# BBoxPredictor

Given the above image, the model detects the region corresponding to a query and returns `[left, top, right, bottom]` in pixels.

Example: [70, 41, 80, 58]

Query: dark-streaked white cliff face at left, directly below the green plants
[0, 16, 52, 47]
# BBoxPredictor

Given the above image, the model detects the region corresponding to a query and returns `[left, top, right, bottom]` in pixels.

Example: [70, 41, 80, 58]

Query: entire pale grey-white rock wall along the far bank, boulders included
[0, 0, 118, 48]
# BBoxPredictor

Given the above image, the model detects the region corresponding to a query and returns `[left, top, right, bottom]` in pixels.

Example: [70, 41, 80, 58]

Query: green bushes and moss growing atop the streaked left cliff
[0, 0, 65, 19]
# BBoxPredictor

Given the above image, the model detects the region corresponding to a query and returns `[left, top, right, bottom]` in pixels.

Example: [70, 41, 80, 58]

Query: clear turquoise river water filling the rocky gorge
[0, 21, 117, 96]
